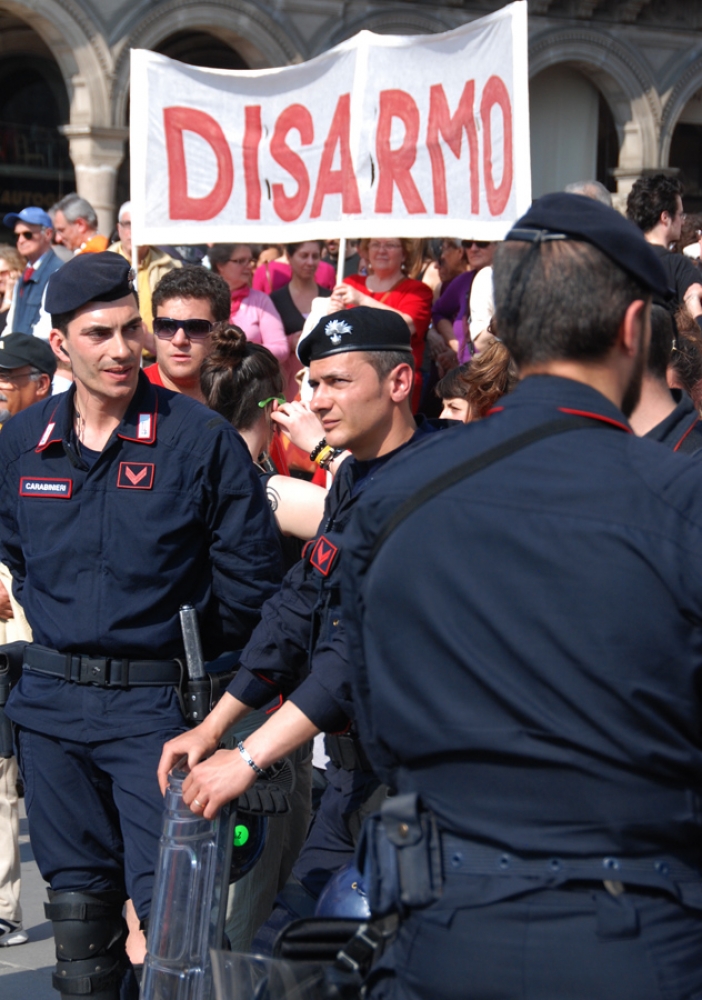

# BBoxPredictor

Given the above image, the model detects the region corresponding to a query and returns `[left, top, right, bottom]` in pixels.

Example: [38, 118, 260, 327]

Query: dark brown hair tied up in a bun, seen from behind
[200, 326, 285, 431]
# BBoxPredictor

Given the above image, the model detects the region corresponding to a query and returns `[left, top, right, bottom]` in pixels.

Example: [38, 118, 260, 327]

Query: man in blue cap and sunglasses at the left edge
[2, 205, 63, 340]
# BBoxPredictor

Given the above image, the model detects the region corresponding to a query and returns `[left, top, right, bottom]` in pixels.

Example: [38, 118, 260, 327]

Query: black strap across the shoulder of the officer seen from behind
[369, 417, 617, 562]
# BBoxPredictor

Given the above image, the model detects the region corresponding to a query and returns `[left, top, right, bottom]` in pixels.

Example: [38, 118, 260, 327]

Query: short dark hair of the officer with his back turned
[493, 240, 651, 368]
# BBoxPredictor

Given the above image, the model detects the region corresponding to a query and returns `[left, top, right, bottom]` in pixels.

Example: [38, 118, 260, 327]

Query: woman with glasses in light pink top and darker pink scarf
[209, 243, 290, 361]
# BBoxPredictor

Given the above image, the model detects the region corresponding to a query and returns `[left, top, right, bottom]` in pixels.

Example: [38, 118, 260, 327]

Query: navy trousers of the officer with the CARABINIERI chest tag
[18, 726, 182, 920]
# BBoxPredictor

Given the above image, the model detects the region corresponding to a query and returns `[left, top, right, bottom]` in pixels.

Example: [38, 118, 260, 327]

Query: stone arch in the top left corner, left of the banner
[0, 0, 112, 126]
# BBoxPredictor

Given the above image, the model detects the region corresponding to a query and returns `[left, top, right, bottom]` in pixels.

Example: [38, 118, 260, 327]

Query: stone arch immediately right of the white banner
[529, 28, 661, 194]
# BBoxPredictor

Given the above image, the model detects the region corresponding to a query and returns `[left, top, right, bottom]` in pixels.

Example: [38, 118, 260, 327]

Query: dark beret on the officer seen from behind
[505, 192, 670, 298]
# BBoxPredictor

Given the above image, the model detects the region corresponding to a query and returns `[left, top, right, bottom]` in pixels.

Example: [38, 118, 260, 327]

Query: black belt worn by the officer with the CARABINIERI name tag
[23, 644, 181, 688]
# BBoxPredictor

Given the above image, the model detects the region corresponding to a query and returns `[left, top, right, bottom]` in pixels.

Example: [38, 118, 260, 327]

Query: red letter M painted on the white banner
[427, 80, 480, 215]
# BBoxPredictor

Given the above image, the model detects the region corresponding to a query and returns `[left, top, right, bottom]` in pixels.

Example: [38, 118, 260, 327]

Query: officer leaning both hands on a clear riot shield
[159, 307, 434, 926]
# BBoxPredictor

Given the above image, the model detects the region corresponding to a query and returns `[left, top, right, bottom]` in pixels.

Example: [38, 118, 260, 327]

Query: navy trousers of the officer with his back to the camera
[369, 883, 702, 1000]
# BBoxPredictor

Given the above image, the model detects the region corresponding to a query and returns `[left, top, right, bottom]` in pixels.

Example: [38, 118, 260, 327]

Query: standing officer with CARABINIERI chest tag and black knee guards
[0, 253, 280, 1000]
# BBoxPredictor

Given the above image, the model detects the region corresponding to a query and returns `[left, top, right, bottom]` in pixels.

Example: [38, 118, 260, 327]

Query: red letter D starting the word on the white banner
[163, 107, 234, 222]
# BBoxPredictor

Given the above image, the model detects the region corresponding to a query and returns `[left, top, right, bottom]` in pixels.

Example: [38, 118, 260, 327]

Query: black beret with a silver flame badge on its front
[297, 306, 410, 367]
